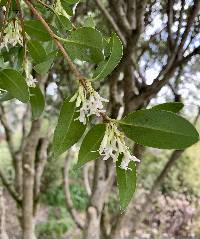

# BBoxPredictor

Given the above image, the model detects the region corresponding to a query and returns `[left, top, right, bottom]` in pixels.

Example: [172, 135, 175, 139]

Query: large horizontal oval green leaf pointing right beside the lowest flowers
[119, 109, 199, 149]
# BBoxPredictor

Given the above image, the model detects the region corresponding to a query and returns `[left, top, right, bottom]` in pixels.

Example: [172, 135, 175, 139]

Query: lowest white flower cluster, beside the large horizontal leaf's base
[99, 122, 139, 170]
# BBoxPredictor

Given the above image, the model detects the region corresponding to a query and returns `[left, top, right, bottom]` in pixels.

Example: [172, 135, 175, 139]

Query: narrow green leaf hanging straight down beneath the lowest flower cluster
[116, 155, 136, 211]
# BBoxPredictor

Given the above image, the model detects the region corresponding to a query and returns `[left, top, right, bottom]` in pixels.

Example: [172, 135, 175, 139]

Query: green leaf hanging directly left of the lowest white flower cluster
[76, 124, 106, 168]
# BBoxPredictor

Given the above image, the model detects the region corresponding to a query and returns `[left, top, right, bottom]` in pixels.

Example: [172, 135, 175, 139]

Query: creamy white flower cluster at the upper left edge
[0, 20, 23, 51]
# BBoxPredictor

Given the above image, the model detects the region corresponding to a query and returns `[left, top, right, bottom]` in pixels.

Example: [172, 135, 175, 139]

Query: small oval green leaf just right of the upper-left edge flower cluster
[27, 40, 47, 63]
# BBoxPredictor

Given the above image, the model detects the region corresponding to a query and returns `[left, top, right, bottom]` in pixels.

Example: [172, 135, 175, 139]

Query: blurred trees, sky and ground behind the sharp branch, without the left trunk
[0, 0, 200, 239]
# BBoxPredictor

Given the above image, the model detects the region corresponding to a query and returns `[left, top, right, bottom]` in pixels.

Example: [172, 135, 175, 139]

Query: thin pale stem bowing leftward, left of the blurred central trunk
[63, 150, 84, 230]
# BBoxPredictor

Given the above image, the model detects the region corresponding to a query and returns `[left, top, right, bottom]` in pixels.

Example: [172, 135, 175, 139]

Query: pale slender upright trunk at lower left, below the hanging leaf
[22, 120, 41, 239]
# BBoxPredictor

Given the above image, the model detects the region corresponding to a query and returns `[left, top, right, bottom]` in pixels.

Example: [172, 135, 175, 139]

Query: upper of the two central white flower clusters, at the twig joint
[71, 81, 108, 124]
